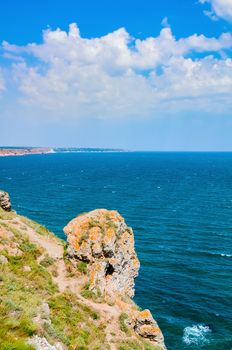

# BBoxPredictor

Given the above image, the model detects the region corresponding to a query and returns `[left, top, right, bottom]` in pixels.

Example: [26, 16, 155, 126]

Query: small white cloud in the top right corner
[199, 0, 232, 22]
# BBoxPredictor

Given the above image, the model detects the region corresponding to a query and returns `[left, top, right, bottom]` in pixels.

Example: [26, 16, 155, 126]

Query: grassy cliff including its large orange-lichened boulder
[0, 193, 165, 350]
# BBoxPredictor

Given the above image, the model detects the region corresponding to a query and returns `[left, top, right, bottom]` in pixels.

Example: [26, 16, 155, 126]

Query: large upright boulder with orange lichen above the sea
[64, 209, 139, 297]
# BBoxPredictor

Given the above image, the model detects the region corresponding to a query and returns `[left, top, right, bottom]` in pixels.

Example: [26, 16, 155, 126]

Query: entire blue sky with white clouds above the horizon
[0, 0, 232, 151]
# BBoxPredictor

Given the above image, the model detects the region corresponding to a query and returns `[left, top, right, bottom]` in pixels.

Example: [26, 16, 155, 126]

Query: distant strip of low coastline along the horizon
[0, 147, 128, 157]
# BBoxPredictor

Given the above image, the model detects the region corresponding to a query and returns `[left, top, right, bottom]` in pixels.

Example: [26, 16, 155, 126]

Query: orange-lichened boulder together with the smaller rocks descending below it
[64, 209, 166, 350]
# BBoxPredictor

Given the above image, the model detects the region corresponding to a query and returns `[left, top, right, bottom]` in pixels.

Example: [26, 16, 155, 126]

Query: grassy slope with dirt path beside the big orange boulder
[0, 197, 166, 350]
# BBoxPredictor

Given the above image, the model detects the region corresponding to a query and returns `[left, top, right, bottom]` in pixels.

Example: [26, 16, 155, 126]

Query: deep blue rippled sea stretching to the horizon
[0, 152, 232, 350]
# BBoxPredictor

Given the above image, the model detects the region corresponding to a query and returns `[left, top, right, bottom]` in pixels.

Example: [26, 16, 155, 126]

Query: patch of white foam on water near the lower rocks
[182, 324, 211, 346]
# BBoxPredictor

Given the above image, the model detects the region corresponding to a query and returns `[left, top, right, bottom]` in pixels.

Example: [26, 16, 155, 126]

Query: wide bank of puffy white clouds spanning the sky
[0, 24, 232, 119]
